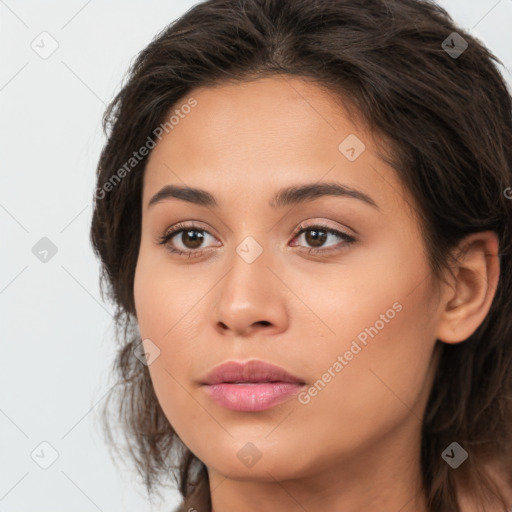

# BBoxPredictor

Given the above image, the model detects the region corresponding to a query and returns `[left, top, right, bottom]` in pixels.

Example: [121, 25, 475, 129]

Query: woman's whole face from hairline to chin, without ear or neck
[134, 77, 440, 488]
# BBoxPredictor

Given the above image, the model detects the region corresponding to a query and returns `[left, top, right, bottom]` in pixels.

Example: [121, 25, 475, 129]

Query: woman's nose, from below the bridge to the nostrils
[211, 245, 289, 337]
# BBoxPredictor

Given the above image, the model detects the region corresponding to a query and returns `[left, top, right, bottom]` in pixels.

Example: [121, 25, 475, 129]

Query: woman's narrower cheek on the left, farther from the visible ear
[134, 248, 212, 434]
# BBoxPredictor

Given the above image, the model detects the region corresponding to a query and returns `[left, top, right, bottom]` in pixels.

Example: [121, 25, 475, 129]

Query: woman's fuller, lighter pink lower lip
[205, 382, 302, 412]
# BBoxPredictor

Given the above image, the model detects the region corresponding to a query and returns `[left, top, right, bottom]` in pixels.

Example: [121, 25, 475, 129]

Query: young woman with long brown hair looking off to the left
[91, 0, 512, 512]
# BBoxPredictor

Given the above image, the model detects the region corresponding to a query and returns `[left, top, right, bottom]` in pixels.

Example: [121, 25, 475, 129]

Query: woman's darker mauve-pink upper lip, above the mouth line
[201, 359, 304, 385]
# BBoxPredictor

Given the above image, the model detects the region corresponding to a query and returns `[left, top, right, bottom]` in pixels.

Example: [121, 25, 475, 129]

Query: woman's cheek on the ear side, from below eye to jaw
[289, 249, 436, 456]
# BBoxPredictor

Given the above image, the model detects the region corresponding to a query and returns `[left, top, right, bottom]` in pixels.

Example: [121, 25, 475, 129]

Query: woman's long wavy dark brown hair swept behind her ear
[91, 0, 512, 512]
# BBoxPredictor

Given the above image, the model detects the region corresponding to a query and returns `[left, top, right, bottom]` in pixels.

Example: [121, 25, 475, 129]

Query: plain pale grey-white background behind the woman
[0, 0, 512, 512]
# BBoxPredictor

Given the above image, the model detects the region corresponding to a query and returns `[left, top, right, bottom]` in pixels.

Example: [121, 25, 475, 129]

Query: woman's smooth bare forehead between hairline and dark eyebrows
[144, 77, 410, 216]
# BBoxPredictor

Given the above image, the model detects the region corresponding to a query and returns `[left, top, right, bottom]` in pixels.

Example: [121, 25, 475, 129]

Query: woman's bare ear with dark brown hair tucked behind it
[437, 231, 500, 343]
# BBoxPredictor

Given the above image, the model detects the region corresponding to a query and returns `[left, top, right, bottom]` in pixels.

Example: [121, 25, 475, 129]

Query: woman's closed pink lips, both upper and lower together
[201, 359, 305, 412]
